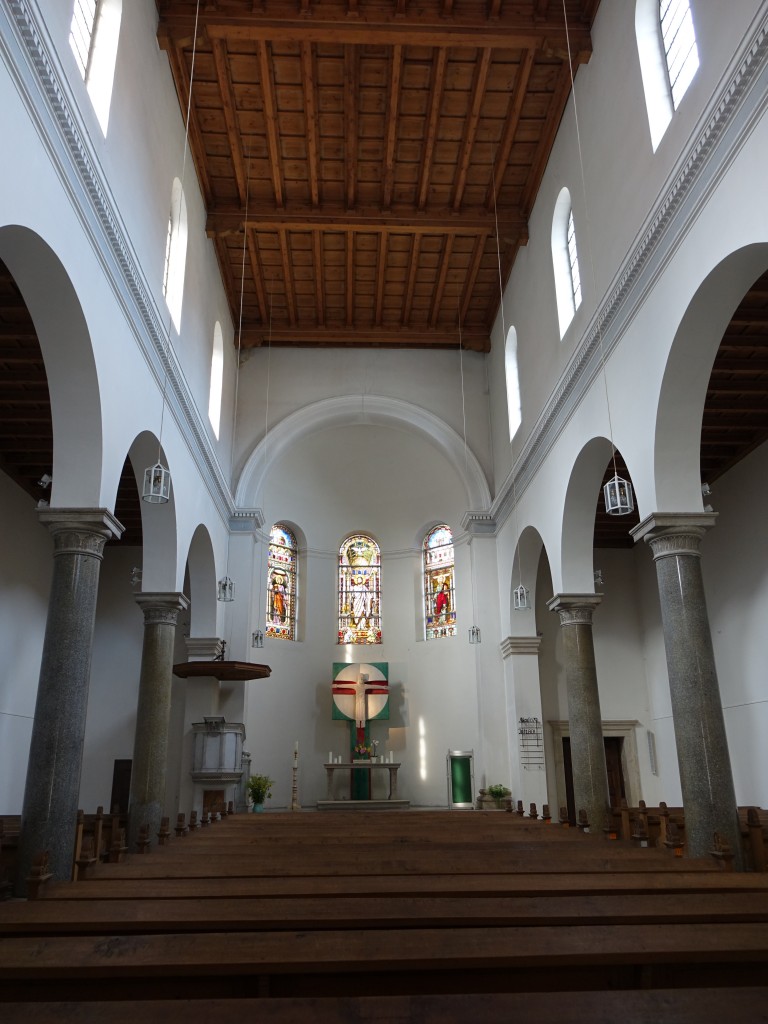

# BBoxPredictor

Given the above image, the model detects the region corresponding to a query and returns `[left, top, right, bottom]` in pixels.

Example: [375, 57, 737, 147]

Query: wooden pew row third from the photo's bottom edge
[0, 880, 768, 937]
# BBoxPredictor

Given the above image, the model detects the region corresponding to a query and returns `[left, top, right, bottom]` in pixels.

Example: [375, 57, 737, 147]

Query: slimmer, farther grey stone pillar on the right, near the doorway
[547, 594, 608, 833]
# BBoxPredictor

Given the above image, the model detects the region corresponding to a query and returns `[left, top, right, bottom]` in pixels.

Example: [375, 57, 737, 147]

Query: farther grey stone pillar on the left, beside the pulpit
[128, 593, 189, 850]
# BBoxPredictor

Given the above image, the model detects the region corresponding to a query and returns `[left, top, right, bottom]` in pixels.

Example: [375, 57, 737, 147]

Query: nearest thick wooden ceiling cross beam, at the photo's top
[158, 11, 592, 52]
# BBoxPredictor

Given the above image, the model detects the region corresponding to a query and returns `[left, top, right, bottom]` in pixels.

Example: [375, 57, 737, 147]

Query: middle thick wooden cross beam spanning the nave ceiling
[206, 204, 528, 233]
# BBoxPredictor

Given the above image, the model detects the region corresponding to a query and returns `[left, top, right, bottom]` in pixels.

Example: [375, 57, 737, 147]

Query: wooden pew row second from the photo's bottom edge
[0, 923, 768, 1000]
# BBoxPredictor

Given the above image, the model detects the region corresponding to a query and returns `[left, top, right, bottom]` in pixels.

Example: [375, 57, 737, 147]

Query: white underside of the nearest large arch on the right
[653, 243, 768, 512]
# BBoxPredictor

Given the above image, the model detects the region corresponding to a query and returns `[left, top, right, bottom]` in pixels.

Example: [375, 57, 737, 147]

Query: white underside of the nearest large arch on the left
[0, 224, 102, 509]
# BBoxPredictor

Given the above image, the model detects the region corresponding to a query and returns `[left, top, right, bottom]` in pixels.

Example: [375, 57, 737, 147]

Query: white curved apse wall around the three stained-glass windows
[246, 425, 498, 806]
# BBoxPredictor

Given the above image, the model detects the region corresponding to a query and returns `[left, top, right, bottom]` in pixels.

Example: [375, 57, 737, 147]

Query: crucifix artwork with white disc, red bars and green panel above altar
[331, 662, 389, 800]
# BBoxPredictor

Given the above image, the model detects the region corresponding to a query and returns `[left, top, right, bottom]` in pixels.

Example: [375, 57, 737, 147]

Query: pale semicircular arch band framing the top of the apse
[234, 394, 490, 512]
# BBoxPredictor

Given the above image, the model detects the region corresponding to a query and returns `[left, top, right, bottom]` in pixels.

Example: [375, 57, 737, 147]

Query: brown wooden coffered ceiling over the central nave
[158, 0, 599, 351]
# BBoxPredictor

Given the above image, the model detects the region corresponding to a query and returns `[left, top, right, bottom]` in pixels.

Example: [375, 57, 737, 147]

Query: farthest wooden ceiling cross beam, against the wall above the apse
[243, 325, 490, 352]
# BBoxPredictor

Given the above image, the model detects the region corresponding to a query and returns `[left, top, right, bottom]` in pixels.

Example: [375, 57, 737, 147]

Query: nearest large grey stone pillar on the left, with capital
[16, 509, 123, 895]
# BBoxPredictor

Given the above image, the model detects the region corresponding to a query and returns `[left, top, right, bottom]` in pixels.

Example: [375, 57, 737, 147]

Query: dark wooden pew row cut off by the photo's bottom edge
[3, 987, 768, 1024]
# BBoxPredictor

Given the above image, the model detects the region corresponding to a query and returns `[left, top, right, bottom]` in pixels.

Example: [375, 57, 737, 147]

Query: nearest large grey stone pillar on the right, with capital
[632, 512, 743, 867]
